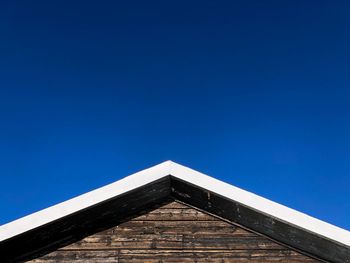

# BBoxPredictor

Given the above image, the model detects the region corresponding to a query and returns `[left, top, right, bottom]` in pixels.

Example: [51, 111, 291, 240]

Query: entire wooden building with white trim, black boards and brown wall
[0, 161, 350, 263]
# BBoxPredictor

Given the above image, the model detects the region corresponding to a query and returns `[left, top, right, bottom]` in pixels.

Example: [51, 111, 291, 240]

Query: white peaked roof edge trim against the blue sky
[0, 161, 350, 249]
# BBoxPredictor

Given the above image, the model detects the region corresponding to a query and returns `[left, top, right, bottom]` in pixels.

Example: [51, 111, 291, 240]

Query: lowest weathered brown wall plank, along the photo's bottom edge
[33, 250, 315, 263]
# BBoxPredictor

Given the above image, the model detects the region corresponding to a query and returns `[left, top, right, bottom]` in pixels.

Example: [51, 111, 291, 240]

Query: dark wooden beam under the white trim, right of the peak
[171, 177, 350, 263]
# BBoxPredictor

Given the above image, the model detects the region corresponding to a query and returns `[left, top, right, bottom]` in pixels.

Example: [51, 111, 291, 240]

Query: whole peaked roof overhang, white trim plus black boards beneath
[0, 161, 350, 263]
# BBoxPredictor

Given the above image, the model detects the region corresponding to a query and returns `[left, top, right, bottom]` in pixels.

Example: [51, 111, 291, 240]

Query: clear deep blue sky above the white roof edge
[0, 0, 350, 229]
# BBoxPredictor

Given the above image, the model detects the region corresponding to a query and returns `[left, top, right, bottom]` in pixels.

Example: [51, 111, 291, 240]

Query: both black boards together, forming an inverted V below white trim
[0, 176, 350, 263]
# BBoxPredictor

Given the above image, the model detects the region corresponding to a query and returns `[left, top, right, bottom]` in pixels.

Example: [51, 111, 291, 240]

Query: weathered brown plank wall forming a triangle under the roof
[30, 202, 319, 263]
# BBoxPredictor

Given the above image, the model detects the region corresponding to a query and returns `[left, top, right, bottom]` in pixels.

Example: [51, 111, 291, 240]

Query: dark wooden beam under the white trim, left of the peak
[0, 177, 170, 263]
